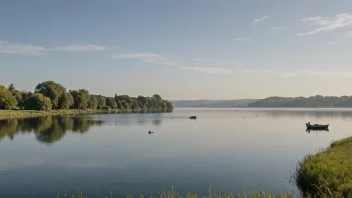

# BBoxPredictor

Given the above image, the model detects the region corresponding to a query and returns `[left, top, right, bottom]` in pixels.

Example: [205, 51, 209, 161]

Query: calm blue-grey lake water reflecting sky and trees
[0, 109, 352, 198]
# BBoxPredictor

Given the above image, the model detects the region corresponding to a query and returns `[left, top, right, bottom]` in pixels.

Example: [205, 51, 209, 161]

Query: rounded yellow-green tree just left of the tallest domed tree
[24, 93, 52, 110]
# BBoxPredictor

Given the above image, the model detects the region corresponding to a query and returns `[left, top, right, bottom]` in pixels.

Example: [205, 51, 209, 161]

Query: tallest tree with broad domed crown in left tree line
[35, 81, 66, 109]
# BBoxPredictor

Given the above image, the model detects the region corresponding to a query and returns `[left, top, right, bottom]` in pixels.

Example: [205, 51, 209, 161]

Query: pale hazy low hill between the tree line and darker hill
[171, 99, 257, 108]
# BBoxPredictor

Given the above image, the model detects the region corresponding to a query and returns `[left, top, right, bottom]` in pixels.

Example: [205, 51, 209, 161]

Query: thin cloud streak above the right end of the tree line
[112, 53, 176, 65]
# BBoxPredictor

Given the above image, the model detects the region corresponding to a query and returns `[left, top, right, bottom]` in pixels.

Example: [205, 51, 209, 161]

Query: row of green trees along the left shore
[0, 81, 173, 111]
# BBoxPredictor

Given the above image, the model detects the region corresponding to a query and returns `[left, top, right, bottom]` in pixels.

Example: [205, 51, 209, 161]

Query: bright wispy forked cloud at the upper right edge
[297, 13, 352, 36]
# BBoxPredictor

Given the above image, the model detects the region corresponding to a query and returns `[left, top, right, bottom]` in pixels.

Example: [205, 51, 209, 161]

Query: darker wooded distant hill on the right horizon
[248, 95, 352, 108]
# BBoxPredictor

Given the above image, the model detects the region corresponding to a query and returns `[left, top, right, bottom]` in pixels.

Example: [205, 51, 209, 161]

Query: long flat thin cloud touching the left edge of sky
[0, 41, 108, 55]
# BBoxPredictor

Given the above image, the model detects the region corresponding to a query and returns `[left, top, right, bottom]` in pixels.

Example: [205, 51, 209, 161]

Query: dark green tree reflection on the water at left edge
[0, 116, 104, 144]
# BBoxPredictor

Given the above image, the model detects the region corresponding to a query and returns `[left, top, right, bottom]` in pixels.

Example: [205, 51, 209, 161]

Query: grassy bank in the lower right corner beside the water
[295, 137, 352, 197]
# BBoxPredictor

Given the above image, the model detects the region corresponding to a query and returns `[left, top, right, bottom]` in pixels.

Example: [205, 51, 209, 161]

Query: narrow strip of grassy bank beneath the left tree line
[0, 109, 172, 119]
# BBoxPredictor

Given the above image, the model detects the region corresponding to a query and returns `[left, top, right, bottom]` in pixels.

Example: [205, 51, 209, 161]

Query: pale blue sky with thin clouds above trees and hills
[0, 0, 352, 100]
